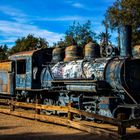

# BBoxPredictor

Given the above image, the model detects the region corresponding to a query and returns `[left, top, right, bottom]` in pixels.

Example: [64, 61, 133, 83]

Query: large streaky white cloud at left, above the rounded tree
[0, 6, 63, 45]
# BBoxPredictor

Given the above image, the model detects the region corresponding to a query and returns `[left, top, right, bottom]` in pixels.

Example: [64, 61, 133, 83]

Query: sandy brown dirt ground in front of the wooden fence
[0, 113, 109, 140]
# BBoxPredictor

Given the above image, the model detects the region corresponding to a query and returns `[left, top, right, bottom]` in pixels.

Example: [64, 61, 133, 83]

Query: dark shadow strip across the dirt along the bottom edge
[0, 133, 108, 140]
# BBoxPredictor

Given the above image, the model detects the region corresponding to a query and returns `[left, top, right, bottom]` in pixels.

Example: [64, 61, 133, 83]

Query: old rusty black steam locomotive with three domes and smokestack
[0, 26, 140, 119]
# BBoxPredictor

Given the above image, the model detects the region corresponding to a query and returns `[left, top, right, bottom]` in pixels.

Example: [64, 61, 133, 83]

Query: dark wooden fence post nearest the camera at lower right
[118, 113, 126, 140]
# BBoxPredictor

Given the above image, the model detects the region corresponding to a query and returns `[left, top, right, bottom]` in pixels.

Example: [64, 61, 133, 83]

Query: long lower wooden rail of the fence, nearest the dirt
[0, 109, 116, 138]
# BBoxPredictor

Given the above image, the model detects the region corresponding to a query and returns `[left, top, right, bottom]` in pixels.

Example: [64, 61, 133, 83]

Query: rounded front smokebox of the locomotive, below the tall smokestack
[105, 58, 140, 95]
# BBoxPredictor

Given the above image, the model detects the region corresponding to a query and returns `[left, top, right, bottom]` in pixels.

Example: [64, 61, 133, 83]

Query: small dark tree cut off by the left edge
[0, 44, 8, 60]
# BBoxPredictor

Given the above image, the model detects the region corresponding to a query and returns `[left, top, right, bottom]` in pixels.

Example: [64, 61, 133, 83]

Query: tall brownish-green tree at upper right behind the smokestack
[105, 0, 140, 46]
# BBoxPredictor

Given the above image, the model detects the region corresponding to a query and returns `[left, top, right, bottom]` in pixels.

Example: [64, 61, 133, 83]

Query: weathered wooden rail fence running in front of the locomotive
[0, 100, 140, 139]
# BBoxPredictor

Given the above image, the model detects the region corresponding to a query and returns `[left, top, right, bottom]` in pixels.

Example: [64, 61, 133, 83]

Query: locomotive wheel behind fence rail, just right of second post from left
[42, 98, 54, 115]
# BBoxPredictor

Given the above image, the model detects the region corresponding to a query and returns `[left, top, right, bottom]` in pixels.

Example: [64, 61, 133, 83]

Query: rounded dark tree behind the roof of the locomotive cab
[10, 34, 48, 54]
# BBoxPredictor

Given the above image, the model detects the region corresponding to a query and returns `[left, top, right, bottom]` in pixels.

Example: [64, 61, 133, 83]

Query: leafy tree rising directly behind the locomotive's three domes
[64, 21, 96, 47]
